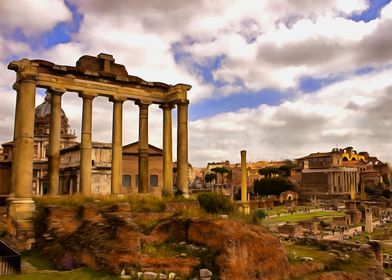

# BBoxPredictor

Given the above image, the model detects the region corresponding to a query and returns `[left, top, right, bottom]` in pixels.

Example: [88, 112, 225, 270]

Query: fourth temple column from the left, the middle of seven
[110, 97, 125, 195]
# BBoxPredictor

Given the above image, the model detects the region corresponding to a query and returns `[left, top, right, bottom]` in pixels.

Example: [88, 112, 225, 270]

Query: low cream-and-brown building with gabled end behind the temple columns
[60, 142, 163, 194]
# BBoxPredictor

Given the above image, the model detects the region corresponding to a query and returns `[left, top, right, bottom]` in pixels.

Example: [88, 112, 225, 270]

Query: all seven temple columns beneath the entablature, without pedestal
[11, 77, 188, 198]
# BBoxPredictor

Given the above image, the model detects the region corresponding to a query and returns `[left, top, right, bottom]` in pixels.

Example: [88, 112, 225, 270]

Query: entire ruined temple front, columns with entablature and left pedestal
[8, 53, 191, 247]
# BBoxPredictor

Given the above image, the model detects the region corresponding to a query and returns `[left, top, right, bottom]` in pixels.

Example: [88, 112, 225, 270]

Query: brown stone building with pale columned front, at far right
[298, 147, 390, 198]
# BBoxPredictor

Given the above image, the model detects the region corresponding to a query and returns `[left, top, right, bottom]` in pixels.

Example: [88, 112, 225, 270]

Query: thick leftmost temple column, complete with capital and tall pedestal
[7, 59, 37, 250]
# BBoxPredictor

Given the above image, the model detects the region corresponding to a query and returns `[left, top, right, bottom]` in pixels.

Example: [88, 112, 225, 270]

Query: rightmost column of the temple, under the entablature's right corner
[177, 100, 189, 198]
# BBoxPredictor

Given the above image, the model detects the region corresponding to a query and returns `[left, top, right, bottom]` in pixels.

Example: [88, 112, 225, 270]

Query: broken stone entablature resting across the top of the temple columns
[8, 53, 191, 104]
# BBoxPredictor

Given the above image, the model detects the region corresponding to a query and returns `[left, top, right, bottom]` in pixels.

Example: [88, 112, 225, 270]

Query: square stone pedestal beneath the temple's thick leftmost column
[6, 198, 35, 251]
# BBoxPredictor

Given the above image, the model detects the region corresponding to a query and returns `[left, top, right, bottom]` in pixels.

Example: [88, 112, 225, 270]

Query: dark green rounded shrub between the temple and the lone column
[197, 192, 234, 214]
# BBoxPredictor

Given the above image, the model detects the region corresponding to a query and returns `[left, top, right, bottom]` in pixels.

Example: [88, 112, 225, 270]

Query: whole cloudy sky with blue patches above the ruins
[0, 0, 392, 167]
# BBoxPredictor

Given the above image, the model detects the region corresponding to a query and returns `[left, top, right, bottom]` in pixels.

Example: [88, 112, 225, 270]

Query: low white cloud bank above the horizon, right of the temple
[190, 69, 392, 166]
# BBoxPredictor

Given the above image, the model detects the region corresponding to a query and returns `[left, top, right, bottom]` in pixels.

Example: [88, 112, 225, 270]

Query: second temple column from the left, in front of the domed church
[48, 89, 65, 195]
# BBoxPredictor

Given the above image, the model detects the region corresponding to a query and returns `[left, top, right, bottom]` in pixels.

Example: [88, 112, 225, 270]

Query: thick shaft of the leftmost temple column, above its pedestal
[11, 77, 36, 198]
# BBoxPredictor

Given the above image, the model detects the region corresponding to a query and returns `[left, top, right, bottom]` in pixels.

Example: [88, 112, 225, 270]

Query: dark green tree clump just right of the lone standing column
[254, 176, 294, 195]
